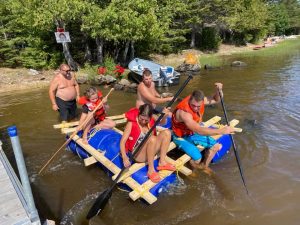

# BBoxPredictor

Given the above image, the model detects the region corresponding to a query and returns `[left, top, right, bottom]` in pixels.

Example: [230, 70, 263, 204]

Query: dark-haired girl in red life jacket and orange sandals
[120, 103, 176, 183]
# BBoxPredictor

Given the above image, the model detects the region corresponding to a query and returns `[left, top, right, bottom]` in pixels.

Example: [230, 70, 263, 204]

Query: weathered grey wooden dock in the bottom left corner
[0, 141, 41, 225]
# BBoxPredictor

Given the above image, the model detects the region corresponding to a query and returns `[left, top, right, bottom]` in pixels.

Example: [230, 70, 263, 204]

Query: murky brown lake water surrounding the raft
[0, 46, 300, 225]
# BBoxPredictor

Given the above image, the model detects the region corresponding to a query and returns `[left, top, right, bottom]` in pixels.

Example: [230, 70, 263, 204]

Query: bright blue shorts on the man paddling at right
[173, 134, 217, 161]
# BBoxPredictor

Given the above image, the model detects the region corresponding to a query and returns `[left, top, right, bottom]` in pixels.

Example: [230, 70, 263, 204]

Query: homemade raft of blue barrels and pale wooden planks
[56, 116, 239, 204]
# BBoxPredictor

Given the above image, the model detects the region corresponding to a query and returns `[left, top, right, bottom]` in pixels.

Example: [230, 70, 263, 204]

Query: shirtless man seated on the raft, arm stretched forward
[136, 69, 173, 113]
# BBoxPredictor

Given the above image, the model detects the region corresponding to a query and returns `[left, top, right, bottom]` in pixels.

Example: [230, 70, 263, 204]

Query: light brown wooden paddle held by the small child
[39, 88, 114, 175]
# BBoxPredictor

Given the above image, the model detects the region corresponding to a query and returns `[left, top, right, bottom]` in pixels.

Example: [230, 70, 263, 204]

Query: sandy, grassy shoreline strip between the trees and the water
[0, 36, 300, 95]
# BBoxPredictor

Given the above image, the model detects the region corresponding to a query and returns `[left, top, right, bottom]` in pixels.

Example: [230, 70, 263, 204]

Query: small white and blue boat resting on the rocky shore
[128, 58, 180, 87]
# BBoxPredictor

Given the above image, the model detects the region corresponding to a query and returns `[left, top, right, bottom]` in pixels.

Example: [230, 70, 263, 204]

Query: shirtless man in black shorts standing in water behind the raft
[49, 64, 80, 121]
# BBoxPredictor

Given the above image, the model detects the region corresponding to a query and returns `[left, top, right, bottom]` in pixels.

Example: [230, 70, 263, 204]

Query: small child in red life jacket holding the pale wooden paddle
[78, 87, 116, 144]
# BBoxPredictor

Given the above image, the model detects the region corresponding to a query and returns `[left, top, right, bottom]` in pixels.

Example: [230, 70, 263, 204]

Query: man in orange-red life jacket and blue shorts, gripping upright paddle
[172, 83, 234, 173]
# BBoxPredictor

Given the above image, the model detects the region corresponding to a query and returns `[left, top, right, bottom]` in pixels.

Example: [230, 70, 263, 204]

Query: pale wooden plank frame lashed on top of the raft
[67, 115, 239, 204]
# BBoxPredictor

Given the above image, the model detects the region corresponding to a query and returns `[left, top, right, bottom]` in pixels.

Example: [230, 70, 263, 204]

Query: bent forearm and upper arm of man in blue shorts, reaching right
[176, 110, 234, 136]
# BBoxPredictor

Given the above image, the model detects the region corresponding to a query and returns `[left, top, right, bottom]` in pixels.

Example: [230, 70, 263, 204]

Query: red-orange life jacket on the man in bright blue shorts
[172, 95, 204, 137]
